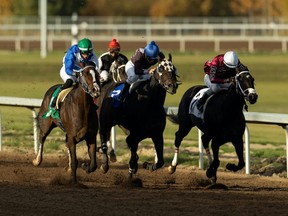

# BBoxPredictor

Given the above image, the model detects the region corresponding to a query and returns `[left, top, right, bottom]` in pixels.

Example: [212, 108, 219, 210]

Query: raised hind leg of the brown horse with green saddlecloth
[33, 117, 56, 166]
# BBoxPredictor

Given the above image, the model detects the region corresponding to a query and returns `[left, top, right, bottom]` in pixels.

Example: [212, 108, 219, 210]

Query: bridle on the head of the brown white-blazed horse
[74, 65, 100, 98]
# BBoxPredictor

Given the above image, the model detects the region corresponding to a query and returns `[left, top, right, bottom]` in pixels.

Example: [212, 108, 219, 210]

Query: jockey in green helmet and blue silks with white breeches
[51, 38, 98, 108]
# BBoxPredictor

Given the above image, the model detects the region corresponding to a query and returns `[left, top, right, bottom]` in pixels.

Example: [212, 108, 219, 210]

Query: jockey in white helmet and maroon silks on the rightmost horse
[197, 51, 248, 111]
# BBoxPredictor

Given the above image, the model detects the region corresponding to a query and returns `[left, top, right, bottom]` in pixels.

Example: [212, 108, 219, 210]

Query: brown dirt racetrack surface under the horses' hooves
[0, 152, 288, 216]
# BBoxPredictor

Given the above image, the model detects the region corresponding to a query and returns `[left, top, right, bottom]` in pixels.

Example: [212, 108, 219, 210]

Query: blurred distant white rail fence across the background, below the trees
[0, 17, 288, 53]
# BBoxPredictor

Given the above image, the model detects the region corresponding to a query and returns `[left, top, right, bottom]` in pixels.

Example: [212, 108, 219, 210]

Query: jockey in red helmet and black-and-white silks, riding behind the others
[98, 38, 128, 83]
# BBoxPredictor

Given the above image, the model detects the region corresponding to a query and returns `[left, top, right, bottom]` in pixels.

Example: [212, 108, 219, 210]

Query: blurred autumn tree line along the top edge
[0, 0, 288, 17]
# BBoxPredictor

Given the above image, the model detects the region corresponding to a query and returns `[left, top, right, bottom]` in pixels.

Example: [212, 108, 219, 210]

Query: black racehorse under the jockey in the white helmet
[168, 71, 258, 183]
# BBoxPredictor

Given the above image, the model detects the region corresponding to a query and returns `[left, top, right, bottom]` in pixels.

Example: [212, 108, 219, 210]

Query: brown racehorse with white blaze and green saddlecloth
[33, 65, 100, 184]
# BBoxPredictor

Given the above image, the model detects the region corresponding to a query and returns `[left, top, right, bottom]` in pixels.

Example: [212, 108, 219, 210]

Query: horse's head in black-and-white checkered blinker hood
[155, 53, 181, 94]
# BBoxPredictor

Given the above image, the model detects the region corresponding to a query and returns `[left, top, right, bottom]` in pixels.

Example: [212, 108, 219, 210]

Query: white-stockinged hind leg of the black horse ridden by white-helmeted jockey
[168, 119, 195, 174]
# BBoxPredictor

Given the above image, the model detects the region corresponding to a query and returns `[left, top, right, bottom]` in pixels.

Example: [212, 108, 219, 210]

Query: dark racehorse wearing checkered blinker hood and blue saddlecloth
[99, 54, 179, 177]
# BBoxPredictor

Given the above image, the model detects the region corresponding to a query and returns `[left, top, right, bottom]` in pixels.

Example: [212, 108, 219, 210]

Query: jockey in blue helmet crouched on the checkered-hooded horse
[119, 41, 165, 101]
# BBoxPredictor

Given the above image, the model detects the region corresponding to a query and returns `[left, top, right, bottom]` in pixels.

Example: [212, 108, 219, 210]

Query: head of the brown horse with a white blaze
[76, 65, 101, 98]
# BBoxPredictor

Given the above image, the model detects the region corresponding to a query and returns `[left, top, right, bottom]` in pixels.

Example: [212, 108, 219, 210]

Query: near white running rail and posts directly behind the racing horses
[0, 97, 288, 177]
